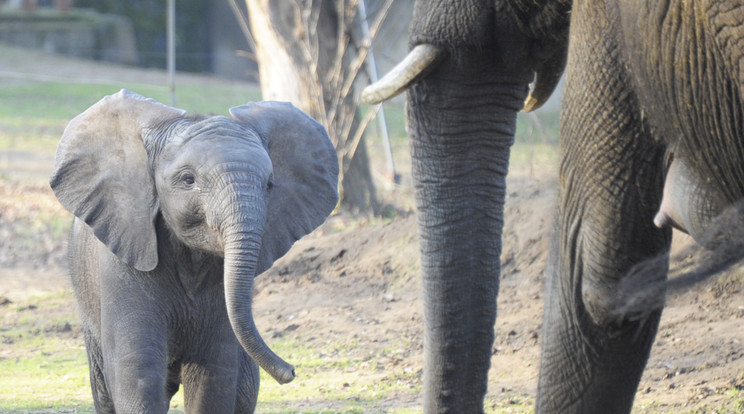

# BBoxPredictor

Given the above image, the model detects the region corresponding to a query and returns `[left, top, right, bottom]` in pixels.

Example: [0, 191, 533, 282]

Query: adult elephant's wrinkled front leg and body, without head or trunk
[537, 0, 744, 413]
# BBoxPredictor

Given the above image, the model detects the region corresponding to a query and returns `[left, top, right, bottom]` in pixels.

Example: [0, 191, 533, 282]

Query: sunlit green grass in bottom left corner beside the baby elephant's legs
[0, 291, 92, 413]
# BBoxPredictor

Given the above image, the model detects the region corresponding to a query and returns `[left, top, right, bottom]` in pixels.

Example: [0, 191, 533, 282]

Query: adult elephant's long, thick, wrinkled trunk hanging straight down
[408, 49, 531, 413]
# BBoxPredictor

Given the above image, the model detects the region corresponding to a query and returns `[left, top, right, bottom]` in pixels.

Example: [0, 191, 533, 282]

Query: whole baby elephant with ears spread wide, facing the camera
[50, 90, 338, 413]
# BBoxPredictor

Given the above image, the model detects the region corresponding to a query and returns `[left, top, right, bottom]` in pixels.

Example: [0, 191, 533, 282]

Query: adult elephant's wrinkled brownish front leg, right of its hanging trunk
[537, 2, 671, 413]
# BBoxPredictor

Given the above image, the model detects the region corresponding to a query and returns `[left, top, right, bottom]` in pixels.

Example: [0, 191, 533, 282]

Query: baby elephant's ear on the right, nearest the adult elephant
[230, 102, 338, 274]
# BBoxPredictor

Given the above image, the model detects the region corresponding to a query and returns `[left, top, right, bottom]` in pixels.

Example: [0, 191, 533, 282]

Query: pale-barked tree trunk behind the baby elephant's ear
[246, 0, 377, 212]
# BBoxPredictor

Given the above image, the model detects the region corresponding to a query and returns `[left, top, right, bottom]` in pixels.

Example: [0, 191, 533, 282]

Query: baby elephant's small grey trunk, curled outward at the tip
[222, 184, 295, 384]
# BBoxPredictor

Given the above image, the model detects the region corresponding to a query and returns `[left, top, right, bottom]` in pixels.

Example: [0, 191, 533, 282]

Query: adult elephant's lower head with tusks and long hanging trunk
[365, 0, 570, 413]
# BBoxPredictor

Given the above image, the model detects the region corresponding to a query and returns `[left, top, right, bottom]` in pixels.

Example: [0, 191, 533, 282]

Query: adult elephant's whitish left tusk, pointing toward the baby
[362, 43, 446, 105]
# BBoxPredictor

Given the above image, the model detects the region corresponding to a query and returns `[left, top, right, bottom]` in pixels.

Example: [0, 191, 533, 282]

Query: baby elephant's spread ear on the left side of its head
[49, 89, 185, 271]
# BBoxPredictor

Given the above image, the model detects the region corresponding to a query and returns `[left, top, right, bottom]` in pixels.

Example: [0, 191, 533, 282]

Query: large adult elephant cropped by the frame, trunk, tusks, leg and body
[365, 0, 744, 413]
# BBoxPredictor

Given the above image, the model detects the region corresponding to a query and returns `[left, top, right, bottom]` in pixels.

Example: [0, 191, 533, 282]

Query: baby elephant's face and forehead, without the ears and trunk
[145, 116, 274, 256]
